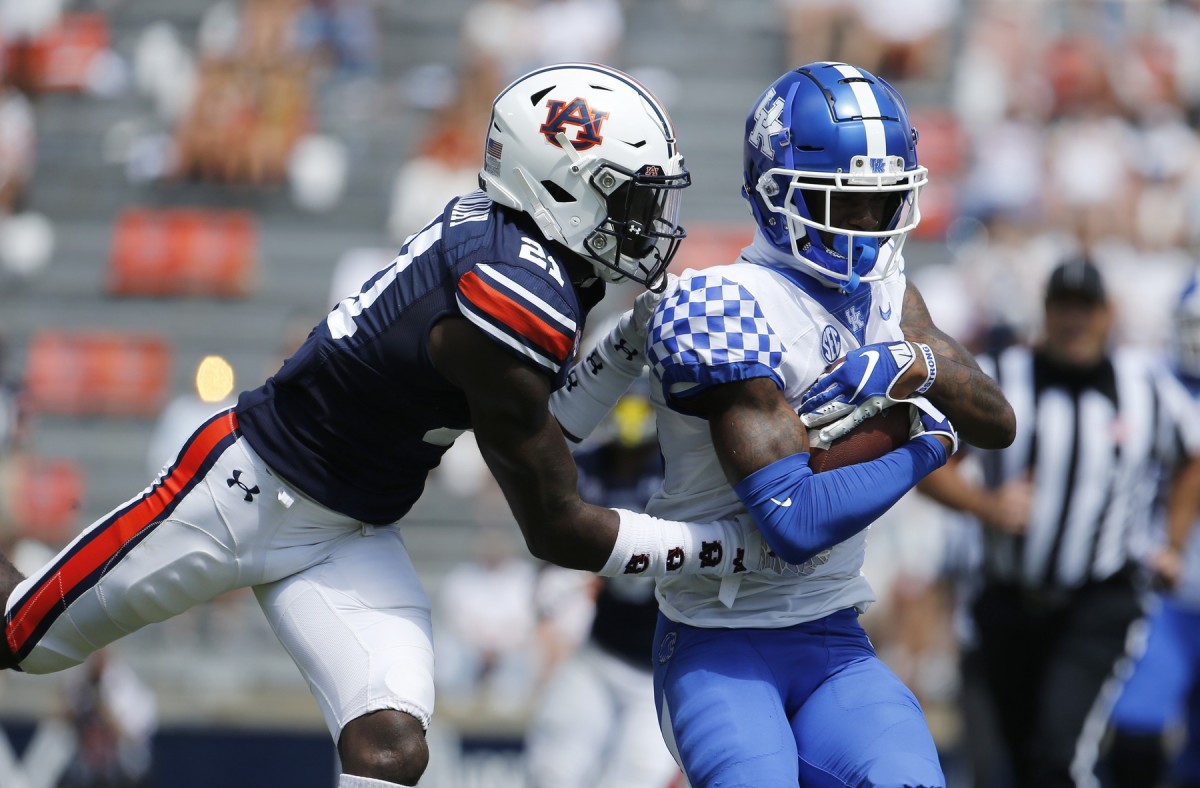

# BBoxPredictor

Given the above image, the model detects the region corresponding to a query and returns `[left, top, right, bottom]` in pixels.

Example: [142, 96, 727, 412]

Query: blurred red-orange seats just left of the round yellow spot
[25, 330, 173, 419]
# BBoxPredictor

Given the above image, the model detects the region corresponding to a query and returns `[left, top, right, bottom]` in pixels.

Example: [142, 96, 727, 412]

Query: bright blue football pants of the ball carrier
[654, 610, 946, 788]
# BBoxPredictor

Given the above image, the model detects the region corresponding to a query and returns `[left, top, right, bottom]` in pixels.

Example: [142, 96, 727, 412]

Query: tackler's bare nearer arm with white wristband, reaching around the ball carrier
[430, 318, 761, 576]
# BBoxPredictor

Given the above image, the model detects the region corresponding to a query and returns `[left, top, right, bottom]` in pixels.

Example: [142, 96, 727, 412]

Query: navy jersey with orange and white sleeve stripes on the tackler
[236, 192, 604, 524]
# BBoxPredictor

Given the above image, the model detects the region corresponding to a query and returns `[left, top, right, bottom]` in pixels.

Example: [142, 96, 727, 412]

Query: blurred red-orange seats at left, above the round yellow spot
[108, 207, 258, 297]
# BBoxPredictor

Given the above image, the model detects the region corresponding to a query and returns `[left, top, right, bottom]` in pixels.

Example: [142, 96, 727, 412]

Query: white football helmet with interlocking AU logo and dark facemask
[479, 64, 691, 289]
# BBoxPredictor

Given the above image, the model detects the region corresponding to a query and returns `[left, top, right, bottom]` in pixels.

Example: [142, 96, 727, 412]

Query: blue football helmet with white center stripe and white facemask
[742, 62, 929, 290]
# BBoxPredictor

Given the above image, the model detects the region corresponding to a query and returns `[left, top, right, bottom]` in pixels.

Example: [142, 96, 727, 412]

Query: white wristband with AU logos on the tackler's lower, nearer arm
[600, 509, 762, 577]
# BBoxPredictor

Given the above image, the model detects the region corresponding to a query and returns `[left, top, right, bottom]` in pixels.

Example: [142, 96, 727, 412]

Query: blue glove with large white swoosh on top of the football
[799, 339, 937, 427]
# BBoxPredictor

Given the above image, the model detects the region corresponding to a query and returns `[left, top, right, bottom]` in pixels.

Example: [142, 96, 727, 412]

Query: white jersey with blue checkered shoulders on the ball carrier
[647, 243, 906, 627]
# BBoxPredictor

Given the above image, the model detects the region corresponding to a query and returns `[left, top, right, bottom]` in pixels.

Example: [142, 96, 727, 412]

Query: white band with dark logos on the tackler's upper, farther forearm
[550, 313, 646, 440]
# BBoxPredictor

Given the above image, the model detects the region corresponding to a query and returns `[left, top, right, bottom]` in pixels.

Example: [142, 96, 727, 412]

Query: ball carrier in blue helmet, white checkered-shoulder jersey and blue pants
[643, 62, 1015, 788]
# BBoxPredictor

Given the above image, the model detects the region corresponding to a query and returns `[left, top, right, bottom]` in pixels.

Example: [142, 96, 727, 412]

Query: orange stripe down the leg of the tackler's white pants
[6, 410, 238, 654]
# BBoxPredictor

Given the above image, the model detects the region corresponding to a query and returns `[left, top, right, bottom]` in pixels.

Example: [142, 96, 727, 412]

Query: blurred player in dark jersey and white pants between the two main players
[526, 383, 680, 788]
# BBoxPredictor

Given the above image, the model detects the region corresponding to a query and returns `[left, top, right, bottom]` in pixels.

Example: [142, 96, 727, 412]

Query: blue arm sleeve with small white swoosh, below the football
[733, 435, 947, 564]
